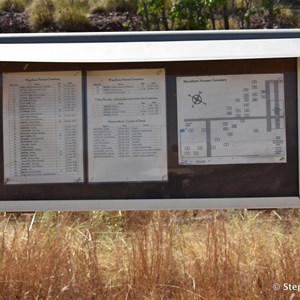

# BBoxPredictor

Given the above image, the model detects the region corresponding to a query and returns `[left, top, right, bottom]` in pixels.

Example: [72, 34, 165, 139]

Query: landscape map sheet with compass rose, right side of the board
[177, 74, 287, 165]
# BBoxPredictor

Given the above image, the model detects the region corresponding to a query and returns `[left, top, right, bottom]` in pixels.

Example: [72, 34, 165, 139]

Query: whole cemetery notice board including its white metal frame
[0, 30, 300, 211]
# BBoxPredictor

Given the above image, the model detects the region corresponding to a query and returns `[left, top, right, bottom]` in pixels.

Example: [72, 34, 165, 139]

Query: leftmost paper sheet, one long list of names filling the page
[3, 71, 83, 184]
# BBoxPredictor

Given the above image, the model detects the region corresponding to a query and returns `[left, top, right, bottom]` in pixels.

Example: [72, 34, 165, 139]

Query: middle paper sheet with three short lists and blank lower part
[87, 69, 168, 182]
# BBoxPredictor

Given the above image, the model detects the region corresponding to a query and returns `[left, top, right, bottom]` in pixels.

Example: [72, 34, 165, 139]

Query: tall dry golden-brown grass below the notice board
[0, 210, 300, 300]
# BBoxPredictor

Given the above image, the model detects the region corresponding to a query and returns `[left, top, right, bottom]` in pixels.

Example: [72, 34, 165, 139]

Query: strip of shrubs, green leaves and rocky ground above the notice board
[0, 0, 300, 32]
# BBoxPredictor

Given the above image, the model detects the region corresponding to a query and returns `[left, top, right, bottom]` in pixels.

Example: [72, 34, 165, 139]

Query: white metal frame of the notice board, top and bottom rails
[0, 30, 300, 211]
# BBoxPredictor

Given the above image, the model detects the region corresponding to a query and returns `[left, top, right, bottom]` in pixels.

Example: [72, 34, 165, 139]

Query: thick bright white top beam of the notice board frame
[0, 30, 300, 62]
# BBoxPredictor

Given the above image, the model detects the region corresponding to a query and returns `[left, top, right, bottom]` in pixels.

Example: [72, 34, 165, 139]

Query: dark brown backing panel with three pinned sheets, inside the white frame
[0, 58, 299, 209]
